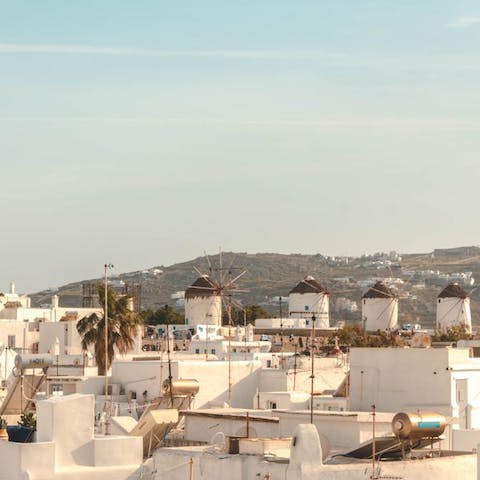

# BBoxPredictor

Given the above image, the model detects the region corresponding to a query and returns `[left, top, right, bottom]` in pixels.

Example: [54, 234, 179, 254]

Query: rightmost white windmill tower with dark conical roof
[437, 283, 472, 332]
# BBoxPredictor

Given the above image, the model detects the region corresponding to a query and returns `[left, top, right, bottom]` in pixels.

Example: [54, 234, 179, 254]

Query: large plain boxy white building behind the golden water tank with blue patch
[350, 348, 480, 428]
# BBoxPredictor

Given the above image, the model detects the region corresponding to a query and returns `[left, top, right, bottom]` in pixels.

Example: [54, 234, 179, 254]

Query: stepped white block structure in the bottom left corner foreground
[0, 395, 144, 480]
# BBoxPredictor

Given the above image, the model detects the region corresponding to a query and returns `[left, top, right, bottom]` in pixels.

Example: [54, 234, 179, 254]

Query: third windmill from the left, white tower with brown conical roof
[362, 281, 398, 332]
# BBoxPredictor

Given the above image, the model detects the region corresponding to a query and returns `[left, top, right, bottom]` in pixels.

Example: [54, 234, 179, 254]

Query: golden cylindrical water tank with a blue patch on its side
[392, 412, 445, 439]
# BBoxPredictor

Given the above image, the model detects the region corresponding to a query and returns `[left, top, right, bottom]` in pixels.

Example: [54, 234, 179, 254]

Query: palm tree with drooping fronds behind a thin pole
[77, 285, 143, 375]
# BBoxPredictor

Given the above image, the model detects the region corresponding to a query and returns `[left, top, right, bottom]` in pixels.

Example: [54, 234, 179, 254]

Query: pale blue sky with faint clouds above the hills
[0, 0, 480, 292]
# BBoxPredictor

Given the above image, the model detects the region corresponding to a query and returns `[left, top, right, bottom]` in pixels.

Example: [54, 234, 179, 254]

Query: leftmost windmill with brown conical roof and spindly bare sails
[185, 275, 222, 328]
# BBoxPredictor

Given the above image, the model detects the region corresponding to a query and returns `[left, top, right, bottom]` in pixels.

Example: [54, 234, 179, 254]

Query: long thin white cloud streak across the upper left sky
[0, 43, 343, 59]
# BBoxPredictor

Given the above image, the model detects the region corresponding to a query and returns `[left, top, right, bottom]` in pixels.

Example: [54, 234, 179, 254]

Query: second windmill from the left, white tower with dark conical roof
[288, 275, 330, 328]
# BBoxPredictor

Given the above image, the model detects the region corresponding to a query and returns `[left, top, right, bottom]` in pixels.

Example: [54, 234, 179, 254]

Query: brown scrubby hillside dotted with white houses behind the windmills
[32, 247, 480, 326]
